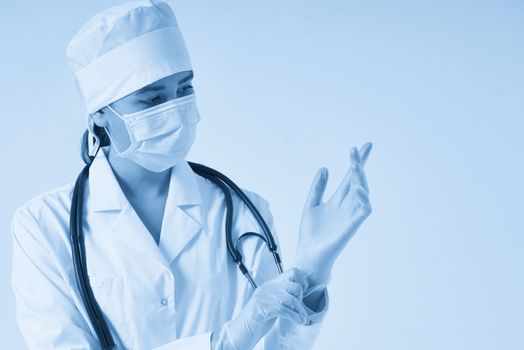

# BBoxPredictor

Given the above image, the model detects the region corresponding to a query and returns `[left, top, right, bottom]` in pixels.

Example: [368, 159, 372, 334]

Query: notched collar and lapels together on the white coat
[89, 149, 204, 268]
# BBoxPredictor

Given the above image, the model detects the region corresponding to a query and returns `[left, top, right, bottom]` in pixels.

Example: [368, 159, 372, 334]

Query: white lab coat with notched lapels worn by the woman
[11, 149, 329, 350]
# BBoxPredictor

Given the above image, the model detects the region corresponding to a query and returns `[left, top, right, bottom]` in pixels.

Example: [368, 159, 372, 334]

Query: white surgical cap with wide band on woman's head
[66, 0, 192, 155]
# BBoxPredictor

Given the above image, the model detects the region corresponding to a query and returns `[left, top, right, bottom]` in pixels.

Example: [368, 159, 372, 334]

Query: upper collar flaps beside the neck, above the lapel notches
[89, 146, 202, 212]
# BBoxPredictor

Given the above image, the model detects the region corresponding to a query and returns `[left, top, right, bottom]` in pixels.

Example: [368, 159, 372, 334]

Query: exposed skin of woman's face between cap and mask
[93, 70, 194, 151]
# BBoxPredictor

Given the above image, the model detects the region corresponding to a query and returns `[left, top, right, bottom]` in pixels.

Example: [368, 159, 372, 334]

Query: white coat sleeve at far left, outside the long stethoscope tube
[11, 209, 100, 350]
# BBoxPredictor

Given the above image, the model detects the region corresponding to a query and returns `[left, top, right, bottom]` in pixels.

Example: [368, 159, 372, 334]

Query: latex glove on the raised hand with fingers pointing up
[295, 142, 372, 296]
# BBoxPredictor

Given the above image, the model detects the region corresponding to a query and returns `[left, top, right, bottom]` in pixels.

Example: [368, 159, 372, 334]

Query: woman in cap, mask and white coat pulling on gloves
[11, 0, 371, 350]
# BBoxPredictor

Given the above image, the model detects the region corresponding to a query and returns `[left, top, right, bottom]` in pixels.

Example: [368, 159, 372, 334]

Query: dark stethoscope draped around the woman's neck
[69, 148, 283, 350]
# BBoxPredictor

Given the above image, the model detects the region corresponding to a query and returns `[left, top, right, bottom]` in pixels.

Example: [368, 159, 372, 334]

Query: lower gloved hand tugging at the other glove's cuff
[217, 268, 309, 350]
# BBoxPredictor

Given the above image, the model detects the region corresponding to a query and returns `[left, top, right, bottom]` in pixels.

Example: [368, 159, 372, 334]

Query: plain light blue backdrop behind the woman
[0, 0, 524, 350]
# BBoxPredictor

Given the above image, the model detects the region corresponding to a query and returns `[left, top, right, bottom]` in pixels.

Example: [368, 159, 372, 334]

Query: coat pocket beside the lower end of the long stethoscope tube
[89, 275, 129, 344]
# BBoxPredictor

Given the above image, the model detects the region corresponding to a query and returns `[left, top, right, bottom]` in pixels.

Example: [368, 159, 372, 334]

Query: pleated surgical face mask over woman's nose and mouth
[106, 93, 200, 172]
